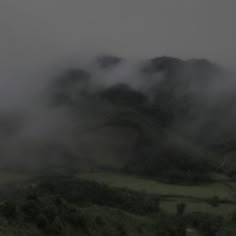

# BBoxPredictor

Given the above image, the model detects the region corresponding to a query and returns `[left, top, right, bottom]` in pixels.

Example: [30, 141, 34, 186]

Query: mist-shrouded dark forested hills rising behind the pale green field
[0, 55, 236, 181]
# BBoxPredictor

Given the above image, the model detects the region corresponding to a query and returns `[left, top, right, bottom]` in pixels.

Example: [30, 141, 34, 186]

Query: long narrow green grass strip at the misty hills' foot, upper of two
[79, 172, 234, 200]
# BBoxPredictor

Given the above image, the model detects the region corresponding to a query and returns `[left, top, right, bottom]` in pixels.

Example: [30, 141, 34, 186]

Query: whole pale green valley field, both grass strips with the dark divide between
[79, 172, 236, 216]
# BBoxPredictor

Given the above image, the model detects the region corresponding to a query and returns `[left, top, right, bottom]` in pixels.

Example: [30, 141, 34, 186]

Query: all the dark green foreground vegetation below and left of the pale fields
[0, 176, 230, 236]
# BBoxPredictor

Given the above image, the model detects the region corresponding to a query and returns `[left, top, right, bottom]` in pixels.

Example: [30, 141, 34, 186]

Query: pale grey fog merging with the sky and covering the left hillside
[0, 0, 236, 171]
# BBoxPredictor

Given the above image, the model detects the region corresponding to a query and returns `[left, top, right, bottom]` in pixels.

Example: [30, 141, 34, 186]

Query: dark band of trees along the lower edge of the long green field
[39, 177, 160, 214]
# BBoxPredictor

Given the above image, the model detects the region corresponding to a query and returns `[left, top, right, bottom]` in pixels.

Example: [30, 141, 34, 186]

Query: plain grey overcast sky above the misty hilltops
[0, 0, 236, 71]
